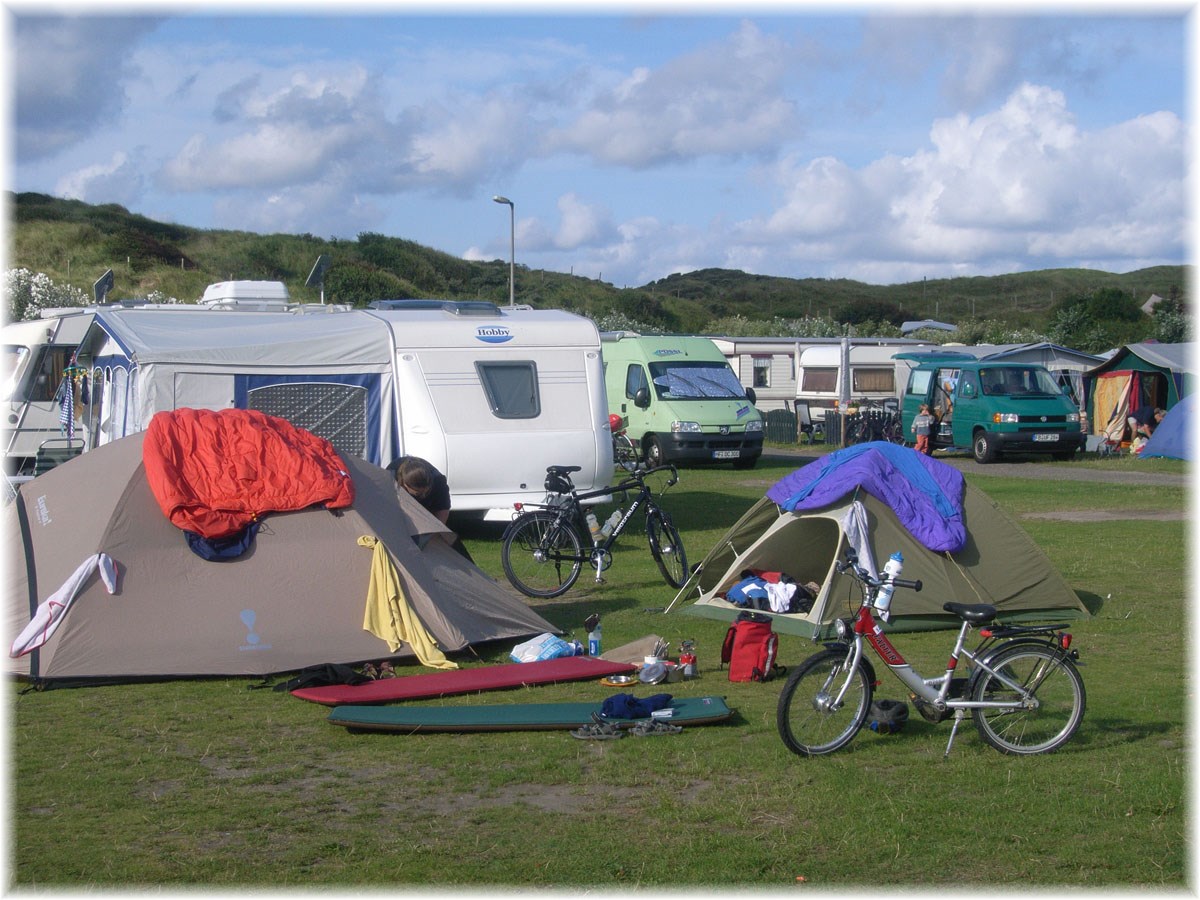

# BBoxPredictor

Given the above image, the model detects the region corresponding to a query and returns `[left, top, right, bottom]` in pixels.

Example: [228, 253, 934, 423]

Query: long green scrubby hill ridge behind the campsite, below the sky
[7, 193, 1189, 340]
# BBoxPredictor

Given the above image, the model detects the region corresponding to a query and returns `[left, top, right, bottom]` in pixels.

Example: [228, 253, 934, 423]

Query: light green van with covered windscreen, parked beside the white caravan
[600, 331, 762, 469]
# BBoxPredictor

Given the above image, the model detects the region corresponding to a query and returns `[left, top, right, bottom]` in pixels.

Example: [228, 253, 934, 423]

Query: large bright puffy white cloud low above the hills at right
[734, 85, 1186, 277]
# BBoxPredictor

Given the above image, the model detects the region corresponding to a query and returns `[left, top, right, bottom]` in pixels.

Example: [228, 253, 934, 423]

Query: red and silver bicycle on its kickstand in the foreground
[775, 551, 1087, 757]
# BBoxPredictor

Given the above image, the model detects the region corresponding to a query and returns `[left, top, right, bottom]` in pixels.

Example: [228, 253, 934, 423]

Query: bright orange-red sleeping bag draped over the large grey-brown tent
[142, 409, 354, 539]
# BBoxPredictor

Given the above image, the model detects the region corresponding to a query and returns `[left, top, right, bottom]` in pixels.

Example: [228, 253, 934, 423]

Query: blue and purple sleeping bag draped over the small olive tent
[767, 440, 967, 553]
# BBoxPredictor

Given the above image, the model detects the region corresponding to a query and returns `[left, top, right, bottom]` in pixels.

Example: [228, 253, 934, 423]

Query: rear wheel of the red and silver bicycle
[971, 644, 1087, 756]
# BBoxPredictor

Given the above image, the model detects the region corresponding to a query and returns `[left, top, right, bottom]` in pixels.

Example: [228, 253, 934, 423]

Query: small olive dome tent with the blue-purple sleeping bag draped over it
[680, 442, 1091, 638]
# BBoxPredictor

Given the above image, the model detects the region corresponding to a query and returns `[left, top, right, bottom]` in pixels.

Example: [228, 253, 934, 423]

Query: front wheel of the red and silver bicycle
[775, 650, 875, 756]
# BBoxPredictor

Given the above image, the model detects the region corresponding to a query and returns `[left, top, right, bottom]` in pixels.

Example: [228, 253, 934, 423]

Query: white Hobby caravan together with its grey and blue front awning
[71, 300, 612, 518]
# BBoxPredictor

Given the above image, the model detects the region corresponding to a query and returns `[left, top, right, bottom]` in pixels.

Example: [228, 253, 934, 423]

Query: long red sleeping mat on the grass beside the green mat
[292, 656, 637, 707]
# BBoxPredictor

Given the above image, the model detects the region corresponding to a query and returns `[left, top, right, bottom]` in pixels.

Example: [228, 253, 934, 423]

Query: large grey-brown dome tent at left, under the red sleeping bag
[4, 434, 558, 680]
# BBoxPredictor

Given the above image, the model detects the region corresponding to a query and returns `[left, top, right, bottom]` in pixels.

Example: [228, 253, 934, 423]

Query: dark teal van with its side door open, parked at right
[895, 352, 1085, 463]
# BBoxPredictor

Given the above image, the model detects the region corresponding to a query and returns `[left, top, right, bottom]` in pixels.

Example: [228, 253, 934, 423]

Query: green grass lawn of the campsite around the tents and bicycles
[10, 460, 1190, 890]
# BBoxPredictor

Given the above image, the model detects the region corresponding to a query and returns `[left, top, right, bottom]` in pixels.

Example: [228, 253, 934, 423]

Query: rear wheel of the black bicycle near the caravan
[500, 510, 583, 596]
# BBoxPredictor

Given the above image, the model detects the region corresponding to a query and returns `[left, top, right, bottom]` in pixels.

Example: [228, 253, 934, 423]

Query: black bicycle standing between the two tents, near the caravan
[500, 466, 688, 598]
